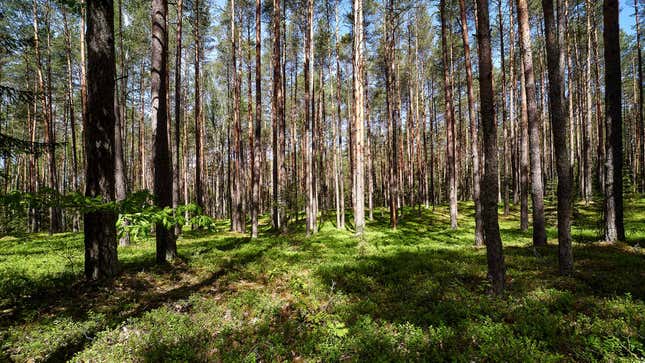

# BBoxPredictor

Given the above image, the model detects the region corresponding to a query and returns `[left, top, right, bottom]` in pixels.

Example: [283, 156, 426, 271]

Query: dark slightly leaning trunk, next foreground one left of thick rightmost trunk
[542, 0, 573, 275]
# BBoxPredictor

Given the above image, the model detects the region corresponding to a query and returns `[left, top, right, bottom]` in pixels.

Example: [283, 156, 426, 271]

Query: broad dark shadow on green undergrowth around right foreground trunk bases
[318, 240, 645, 327]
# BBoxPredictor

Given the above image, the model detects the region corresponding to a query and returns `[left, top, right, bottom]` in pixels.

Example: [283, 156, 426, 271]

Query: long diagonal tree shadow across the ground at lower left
[0, 237, 268, 362]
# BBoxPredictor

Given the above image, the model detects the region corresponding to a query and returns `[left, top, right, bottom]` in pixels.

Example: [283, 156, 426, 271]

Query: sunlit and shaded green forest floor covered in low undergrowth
[0, 199, 645, 362]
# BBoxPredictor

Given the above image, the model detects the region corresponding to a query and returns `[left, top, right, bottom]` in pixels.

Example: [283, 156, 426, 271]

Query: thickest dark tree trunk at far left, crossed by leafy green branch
[83, 0, 118, 280]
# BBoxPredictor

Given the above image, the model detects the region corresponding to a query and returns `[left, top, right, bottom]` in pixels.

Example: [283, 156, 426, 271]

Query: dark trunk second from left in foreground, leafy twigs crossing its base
[150, 0, 177, 263]
